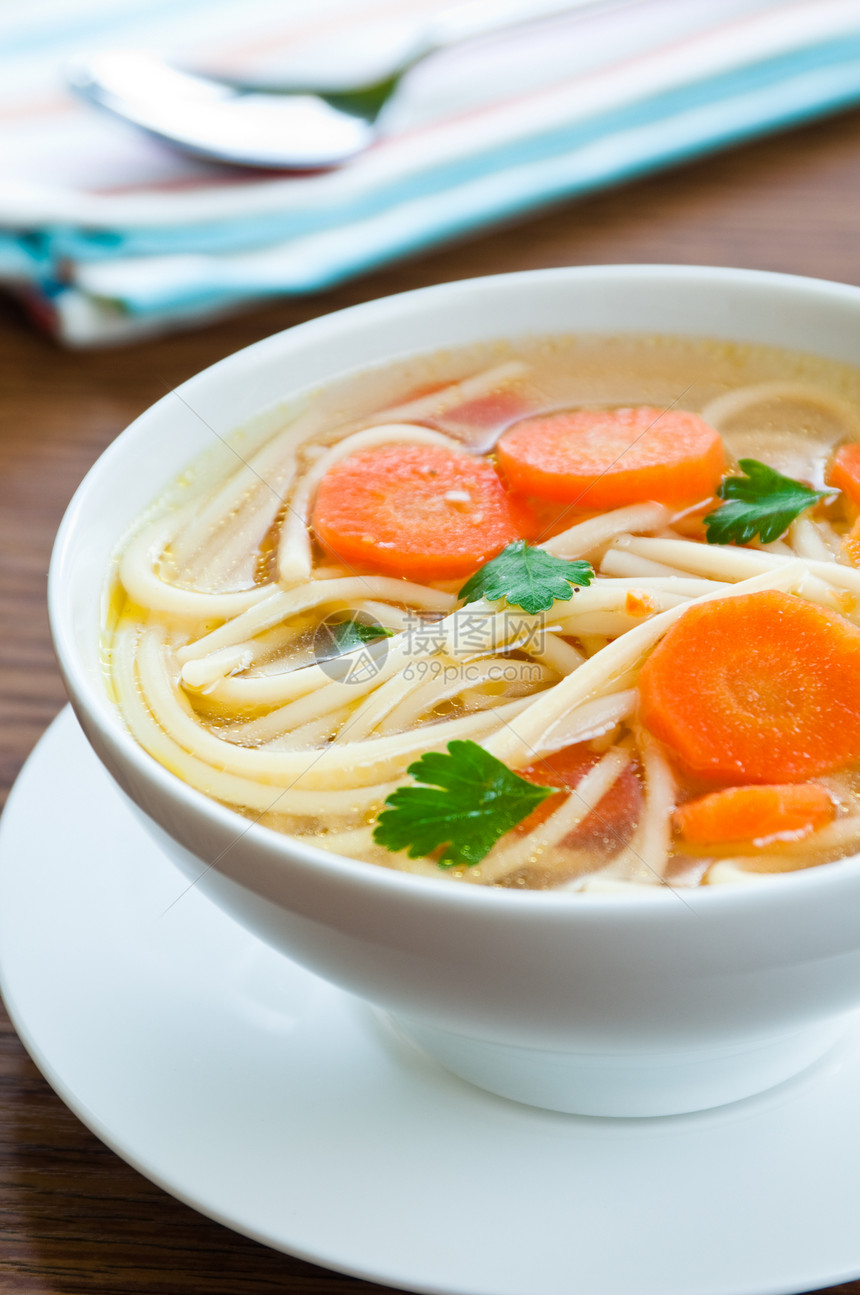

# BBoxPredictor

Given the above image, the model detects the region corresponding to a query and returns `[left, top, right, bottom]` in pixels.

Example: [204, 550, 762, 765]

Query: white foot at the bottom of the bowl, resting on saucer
[392, 1015, 851, 1118]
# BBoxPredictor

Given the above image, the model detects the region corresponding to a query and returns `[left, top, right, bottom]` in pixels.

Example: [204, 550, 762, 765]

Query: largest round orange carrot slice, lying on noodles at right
[639, 591, 860, 782]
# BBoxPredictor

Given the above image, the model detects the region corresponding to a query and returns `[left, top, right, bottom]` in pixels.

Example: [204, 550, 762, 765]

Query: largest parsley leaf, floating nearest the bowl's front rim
[373, 742, 556, 868]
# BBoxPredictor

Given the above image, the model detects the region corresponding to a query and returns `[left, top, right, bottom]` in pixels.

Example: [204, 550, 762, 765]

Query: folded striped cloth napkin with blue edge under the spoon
[0, 0, 860, 346]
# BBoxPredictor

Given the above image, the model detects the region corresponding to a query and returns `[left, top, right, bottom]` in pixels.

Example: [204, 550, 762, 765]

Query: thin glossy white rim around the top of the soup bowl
[48, 263, 860, 923]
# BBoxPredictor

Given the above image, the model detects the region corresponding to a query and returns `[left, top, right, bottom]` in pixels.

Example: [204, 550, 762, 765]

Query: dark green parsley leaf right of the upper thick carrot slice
[705, 458, 833, 544]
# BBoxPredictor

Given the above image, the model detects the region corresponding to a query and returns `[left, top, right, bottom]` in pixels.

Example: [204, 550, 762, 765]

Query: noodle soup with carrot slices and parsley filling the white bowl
[105, 337, 860, 892]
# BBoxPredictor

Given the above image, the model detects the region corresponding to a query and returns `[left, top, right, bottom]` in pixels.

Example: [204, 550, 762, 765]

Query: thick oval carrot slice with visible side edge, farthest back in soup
[497, 405, 725, 509]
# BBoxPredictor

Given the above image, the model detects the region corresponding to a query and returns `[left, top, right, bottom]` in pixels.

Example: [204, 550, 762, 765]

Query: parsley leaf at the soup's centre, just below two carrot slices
[457, 540, 594, 613]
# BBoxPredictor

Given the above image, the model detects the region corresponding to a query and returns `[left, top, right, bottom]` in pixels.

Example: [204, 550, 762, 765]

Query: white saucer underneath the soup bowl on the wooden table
[0, 712, 860, 1295]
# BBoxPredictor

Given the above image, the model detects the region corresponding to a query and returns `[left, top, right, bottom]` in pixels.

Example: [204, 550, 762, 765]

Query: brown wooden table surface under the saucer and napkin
[0, 113, 860, 1295]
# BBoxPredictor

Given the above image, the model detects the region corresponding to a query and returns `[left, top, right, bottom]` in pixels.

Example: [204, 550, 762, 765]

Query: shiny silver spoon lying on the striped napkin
[67, 0, 636, 171]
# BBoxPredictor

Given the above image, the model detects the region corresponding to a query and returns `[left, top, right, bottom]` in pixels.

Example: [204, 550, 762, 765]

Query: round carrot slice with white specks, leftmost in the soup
[312, 444, 535, 580]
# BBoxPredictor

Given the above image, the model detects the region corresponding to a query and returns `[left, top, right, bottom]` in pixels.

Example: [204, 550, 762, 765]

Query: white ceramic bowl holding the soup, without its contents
[49, 265, 860, 1115]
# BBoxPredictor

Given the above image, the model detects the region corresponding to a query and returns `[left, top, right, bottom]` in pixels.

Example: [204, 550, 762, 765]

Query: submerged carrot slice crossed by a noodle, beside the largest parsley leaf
[514, 742, 642, 853]
